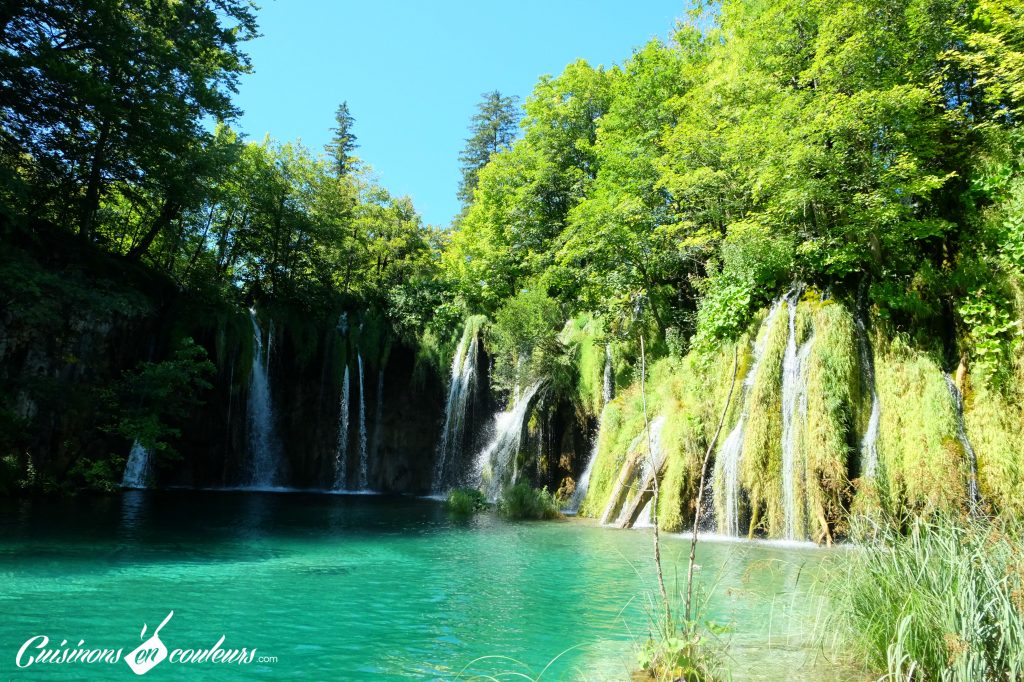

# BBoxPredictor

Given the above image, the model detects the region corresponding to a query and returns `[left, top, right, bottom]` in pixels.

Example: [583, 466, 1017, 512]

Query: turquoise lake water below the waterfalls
[0, 491, 844, 680]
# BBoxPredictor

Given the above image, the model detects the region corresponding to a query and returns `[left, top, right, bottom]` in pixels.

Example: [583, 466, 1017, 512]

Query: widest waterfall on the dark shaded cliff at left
[247, 309, 281, 487]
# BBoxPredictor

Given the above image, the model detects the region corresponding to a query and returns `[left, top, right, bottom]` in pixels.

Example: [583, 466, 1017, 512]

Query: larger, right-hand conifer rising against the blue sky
[459, 90, 519, 205]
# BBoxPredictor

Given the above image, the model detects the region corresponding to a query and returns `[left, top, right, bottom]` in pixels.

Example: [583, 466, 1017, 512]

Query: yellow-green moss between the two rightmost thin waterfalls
[876, 335, 966, 512]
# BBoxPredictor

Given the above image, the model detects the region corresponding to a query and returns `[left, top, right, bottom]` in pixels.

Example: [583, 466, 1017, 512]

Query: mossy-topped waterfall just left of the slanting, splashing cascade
[432, 321, 479, 493]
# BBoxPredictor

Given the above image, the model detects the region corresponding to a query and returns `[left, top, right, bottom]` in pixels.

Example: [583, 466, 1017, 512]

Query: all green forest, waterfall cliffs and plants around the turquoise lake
[0, 0, 1024, 680]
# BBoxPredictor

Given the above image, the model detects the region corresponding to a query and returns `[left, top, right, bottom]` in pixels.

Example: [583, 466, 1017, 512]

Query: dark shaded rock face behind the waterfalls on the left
[0, 236, 443, 493]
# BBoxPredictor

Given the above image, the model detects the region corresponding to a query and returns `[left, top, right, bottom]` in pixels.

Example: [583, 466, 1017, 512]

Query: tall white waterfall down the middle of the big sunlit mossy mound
[782, 290, 814, 540]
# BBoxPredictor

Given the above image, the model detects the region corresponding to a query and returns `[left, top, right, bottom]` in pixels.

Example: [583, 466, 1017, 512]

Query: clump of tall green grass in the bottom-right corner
[834, 516, 1024, 682]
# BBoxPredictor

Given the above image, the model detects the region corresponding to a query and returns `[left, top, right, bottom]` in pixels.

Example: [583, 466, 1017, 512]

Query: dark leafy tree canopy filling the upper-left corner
[0, 0, 256, 241]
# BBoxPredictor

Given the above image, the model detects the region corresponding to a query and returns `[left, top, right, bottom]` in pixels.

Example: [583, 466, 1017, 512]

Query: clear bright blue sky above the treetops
[236, 0, 685, 225]
